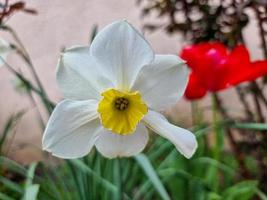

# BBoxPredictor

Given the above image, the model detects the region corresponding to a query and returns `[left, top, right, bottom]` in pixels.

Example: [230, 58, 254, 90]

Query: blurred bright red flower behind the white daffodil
[181, 42, 267, 100]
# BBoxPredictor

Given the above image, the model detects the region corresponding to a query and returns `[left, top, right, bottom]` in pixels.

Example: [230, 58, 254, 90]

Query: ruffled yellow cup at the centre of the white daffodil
[97, 89, 148, 135]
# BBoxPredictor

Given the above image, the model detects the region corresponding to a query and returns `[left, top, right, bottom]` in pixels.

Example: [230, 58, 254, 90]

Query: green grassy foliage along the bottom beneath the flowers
[0, 126, 266, 200]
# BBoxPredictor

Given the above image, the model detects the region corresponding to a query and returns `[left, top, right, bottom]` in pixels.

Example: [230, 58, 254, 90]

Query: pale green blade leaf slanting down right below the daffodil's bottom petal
[134, 154, 171, 200]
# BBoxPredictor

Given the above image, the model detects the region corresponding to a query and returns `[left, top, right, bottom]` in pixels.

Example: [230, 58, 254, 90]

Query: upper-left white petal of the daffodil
[57, 46, 114, 100]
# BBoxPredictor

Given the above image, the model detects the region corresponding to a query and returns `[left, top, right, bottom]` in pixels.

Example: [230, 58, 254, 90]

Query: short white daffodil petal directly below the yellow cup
[95, 124, 149, 158]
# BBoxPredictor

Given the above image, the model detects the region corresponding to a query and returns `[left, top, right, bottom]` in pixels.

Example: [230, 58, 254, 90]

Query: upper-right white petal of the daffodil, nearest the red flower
[133, 55, 188, 110]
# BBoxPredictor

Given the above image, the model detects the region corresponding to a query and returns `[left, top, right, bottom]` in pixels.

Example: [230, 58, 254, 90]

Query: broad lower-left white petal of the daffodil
[42, 100, 101, 158]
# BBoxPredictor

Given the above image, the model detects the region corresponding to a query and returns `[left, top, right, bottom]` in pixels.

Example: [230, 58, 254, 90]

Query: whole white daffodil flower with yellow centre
[42, 21, 197, 158]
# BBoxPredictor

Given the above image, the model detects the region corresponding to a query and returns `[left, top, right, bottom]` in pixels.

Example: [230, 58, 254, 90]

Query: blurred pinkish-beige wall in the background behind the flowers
[0, 0, 260, 162]
